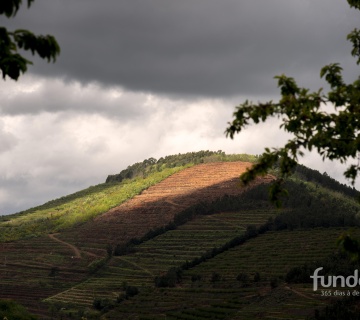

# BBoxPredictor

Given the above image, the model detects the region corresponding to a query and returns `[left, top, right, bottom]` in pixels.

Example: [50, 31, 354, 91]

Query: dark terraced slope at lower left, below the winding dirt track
[0, 236, 94, 319]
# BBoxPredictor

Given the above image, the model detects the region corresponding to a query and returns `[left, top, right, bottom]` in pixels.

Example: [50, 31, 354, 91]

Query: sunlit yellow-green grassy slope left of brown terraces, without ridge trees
[0, 164, 191, 242]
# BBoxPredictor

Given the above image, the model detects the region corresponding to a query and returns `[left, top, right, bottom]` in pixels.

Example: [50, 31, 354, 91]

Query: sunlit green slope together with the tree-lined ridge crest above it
[0, 151, 257, 241]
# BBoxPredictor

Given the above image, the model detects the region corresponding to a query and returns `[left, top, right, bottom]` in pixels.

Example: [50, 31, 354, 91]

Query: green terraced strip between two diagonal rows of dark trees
[47, 209, 277, 307]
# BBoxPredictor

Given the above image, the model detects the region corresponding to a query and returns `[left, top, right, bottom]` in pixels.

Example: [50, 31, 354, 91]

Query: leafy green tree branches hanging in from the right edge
[226, 0, 360, 198]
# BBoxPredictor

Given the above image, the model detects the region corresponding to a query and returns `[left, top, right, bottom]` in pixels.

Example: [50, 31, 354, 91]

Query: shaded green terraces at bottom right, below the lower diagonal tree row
[104, 228, 360, 320]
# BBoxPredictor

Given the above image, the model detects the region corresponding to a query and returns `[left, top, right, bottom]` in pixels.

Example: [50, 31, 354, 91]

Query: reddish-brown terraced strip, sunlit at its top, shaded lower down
[59, 162, 272, 253]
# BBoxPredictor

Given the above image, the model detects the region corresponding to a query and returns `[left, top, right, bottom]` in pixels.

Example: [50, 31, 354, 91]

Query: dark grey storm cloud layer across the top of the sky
[4, 0, 357, 96]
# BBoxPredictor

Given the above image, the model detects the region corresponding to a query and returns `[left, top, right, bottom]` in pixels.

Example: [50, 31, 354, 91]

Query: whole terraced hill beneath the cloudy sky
[0, 151, 360, 320]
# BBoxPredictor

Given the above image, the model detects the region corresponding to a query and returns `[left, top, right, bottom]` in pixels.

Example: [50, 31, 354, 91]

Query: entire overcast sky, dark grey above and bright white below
[0, 0, 359, 214]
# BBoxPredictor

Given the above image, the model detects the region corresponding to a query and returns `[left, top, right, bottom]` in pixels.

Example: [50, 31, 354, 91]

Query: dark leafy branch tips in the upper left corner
[0, 0, 60, 80]
